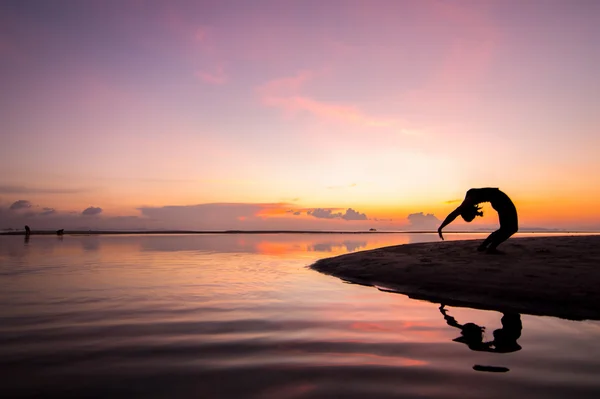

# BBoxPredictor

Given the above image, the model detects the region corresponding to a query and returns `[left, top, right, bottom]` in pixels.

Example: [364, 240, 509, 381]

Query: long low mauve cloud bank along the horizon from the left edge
[0, 200, 367, 231]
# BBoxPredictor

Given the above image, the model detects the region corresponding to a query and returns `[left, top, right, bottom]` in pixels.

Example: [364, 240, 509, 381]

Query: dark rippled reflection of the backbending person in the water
[440, 305, 523, 353]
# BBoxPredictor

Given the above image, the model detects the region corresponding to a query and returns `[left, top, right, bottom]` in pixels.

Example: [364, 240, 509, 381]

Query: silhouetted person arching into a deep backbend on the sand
[438, 187, 519, 254]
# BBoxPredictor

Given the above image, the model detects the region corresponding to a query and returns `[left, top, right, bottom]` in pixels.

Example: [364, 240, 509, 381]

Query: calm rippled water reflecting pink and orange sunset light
[0, 234, 600, 398]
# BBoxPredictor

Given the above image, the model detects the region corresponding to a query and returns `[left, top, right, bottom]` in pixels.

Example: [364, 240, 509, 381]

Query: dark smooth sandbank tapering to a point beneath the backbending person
[311, 236, 600, 320]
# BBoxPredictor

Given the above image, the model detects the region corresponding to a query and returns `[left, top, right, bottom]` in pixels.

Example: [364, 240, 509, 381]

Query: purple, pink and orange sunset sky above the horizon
[0, 0, 600, 230]
